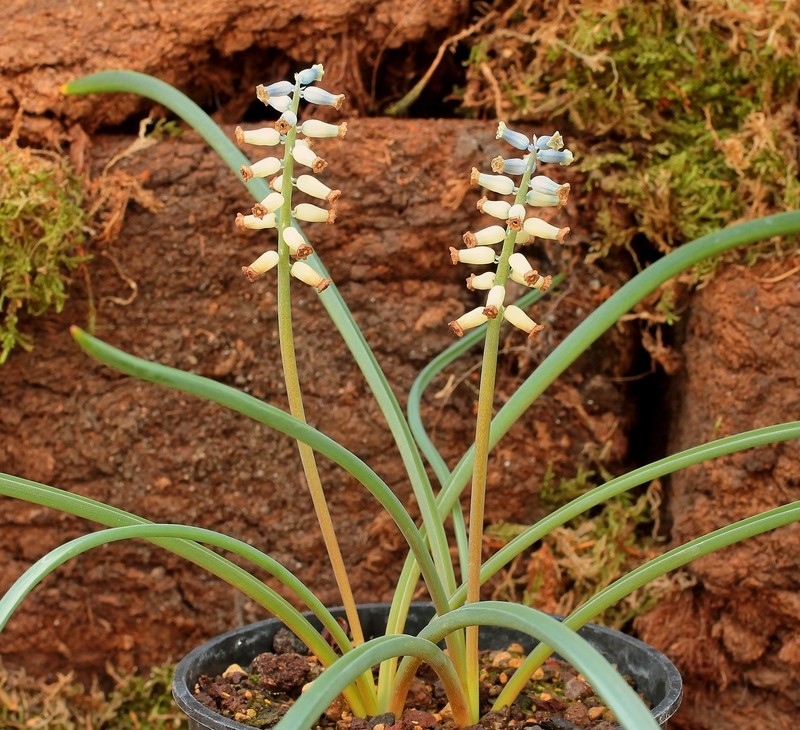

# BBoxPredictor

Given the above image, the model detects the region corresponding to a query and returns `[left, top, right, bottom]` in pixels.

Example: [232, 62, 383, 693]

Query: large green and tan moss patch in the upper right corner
[464, 0, 800, 256]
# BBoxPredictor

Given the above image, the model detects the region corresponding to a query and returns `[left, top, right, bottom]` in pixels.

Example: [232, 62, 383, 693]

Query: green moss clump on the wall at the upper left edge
[0, 135, 89, 364]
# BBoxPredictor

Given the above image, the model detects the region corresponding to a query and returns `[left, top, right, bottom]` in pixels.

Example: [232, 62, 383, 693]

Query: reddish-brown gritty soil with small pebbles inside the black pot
[195, 637, 618, 730]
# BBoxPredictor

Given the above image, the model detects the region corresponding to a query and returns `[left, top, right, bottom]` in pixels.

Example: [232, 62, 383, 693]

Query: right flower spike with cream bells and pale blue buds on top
[450, 122, 573, 338]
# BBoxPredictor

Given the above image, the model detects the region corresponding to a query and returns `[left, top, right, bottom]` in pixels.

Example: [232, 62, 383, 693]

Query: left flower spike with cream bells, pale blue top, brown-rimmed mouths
[235, 63, 347, 291]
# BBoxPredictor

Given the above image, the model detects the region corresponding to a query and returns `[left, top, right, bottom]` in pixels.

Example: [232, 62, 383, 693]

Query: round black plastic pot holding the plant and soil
[172, 603, 683, 730]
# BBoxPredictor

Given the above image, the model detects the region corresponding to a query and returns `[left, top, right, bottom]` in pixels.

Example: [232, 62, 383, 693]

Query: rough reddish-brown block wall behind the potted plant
[0, 0, 800, 730]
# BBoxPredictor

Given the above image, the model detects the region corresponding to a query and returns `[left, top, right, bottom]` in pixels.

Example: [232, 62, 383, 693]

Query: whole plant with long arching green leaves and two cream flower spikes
[0, 64, 800, 730]
